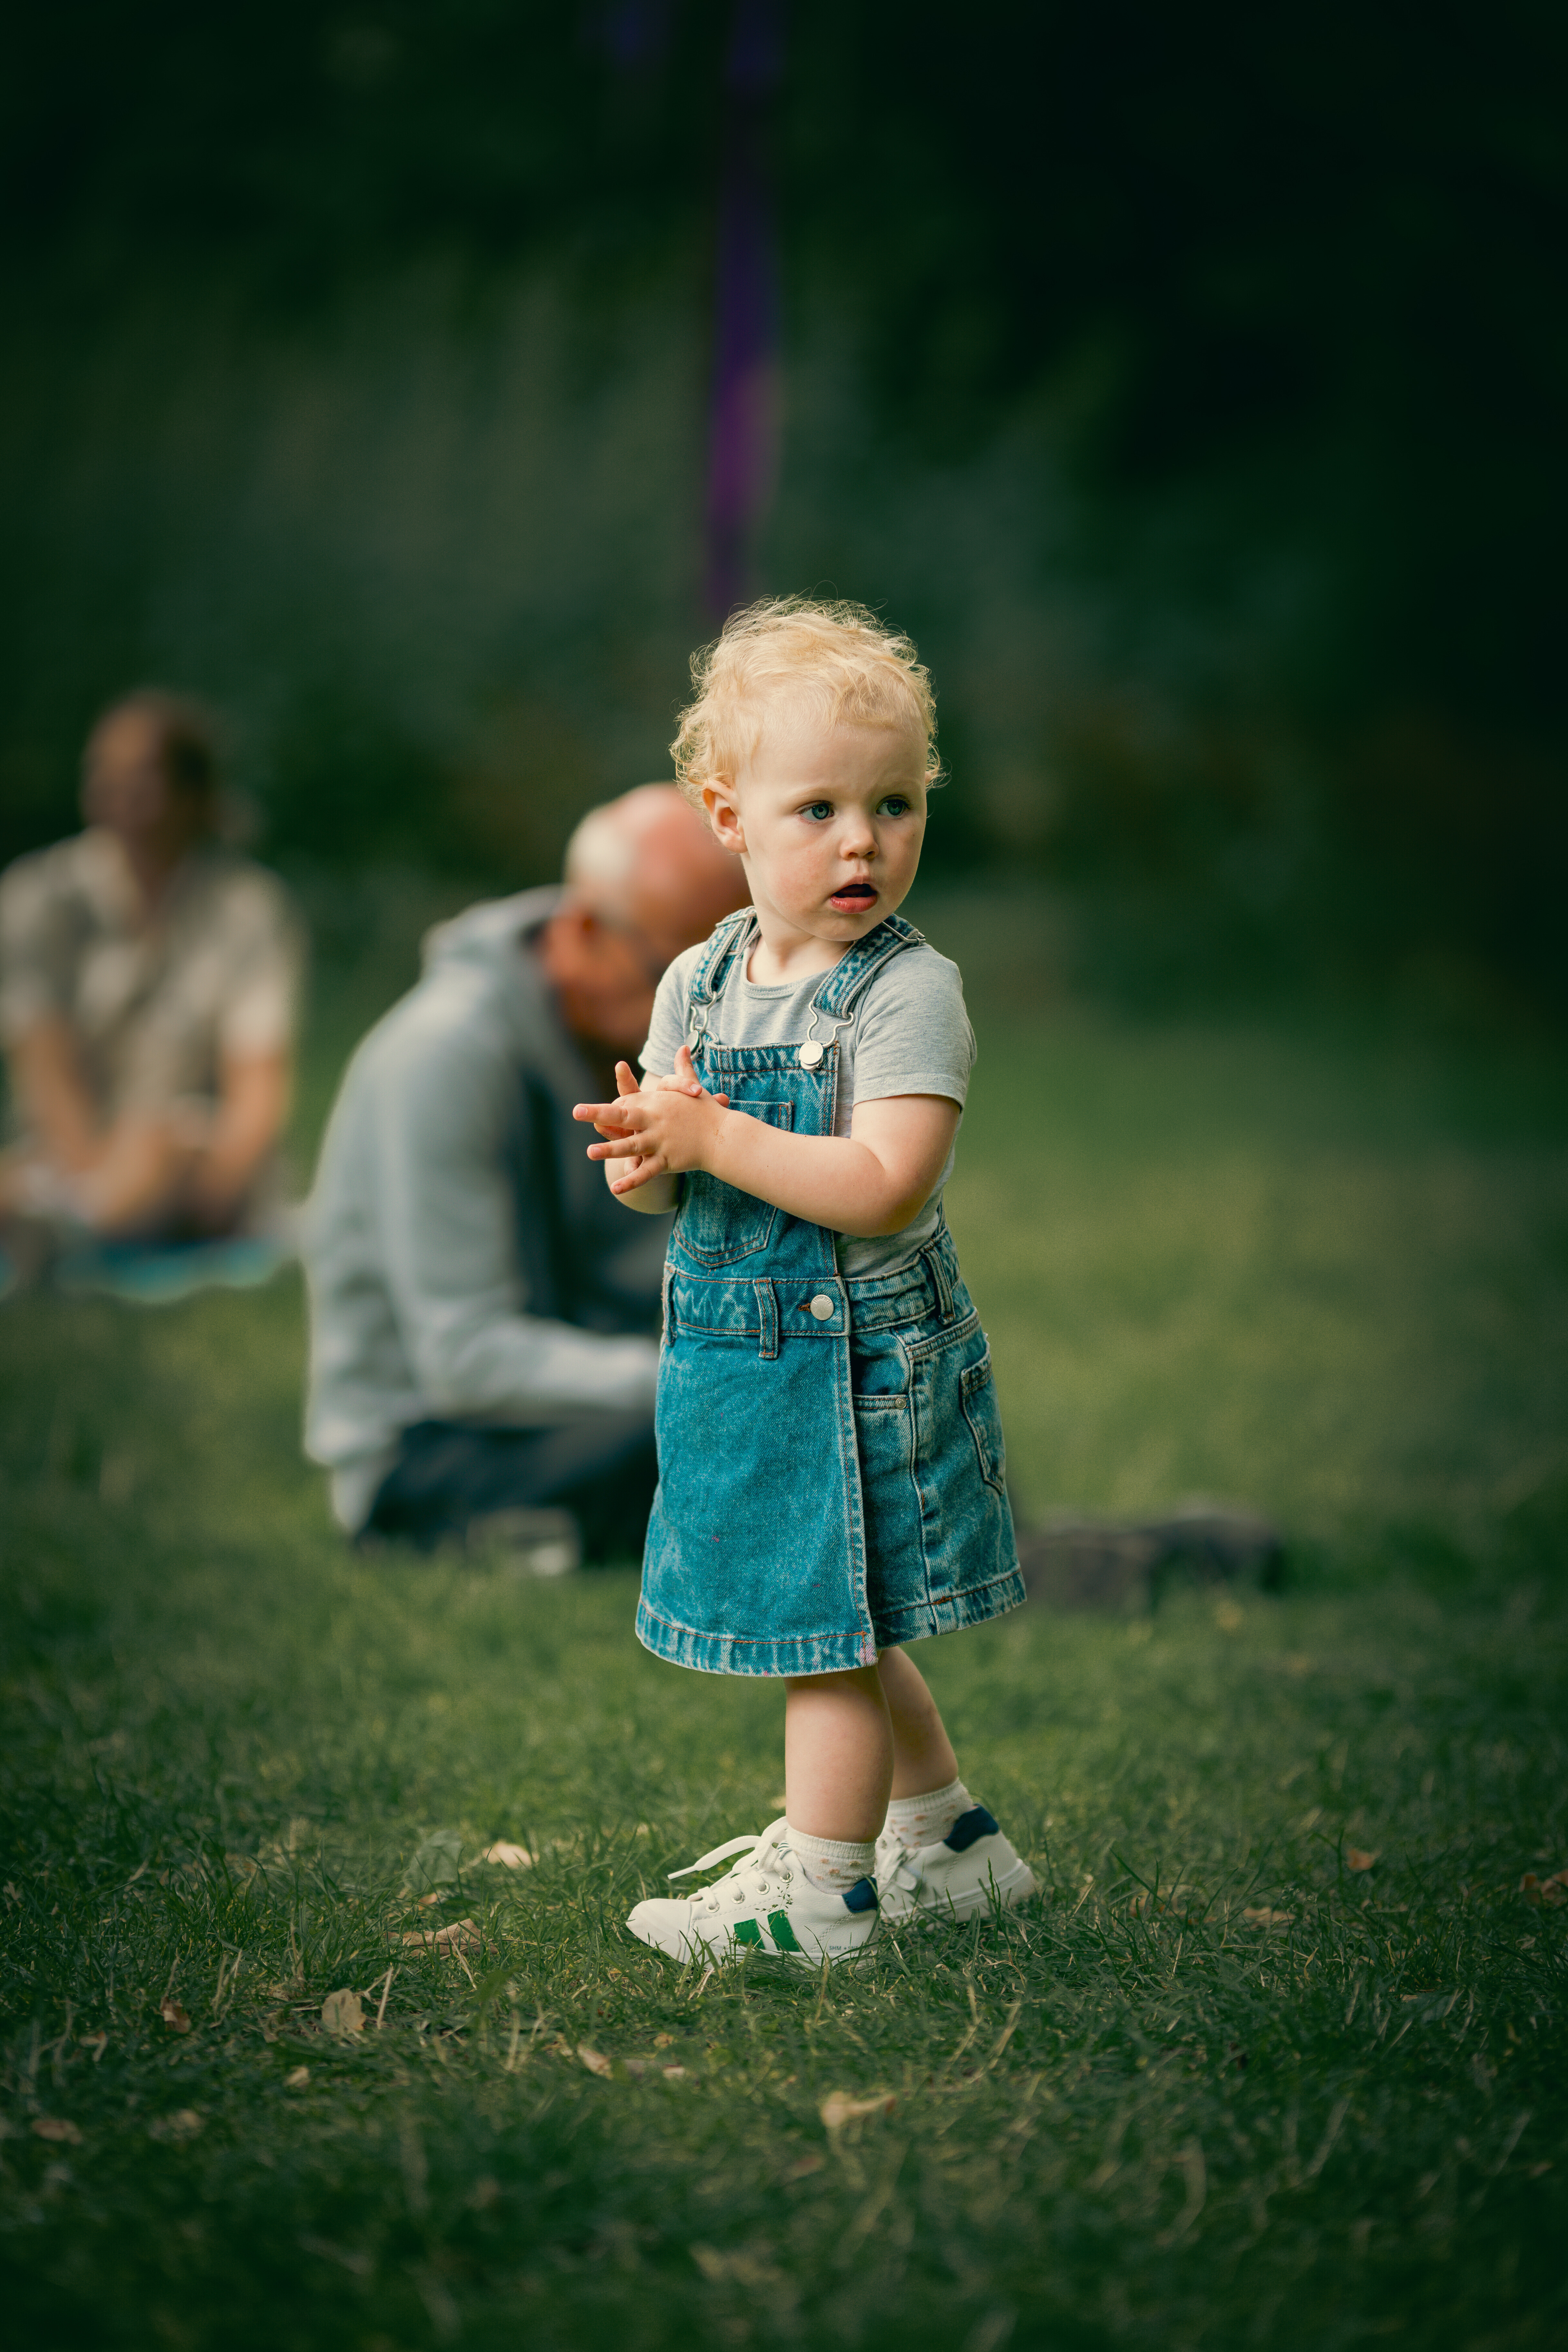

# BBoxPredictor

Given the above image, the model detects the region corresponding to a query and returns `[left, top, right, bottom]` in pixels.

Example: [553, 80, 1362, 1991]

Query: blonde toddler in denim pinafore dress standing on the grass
[576, 600, 1034, 1964]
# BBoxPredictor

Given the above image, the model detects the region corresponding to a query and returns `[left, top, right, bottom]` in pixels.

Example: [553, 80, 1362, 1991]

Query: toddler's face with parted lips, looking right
[703, 713, 926, 945]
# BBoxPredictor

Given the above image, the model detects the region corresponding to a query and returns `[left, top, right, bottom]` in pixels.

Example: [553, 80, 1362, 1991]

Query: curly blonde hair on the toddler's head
[670, 595, 943, 809]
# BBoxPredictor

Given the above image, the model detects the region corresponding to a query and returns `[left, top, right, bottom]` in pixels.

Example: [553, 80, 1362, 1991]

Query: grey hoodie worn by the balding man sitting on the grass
[306, 889, 665, 1529]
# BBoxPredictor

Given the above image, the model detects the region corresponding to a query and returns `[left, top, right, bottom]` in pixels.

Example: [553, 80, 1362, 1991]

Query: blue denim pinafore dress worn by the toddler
[637, 908, 1022, 1674]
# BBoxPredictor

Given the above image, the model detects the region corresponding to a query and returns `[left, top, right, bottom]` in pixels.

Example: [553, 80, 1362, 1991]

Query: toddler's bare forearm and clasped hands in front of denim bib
[574, 1047, 959, 1237]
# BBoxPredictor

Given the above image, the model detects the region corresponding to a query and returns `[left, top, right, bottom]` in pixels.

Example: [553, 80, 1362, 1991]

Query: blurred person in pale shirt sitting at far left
[0, 689, 303, 1272]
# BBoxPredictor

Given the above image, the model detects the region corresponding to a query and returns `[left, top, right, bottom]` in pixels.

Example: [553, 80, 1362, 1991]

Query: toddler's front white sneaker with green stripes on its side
[625, 1820, 877, 1968]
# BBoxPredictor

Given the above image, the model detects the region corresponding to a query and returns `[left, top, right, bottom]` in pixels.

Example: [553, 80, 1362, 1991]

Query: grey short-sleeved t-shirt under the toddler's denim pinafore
[640, 922, 975, 1277]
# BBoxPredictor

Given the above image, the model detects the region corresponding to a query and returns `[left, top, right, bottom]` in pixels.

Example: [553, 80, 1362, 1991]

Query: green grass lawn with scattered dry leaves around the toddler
[0, 908, 1568, 2352]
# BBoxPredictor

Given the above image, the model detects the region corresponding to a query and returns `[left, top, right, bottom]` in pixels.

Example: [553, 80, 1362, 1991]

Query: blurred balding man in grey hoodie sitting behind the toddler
[306, 783, 745, 1571]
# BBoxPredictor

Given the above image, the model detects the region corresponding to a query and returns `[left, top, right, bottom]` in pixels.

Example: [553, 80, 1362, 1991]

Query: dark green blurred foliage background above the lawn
[0, 0, 1568, 1004]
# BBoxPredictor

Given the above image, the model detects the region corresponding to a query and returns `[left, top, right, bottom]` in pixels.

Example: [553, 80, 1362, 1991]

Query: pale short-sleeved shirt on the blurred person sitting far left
[0, 828, 303, 1120]
